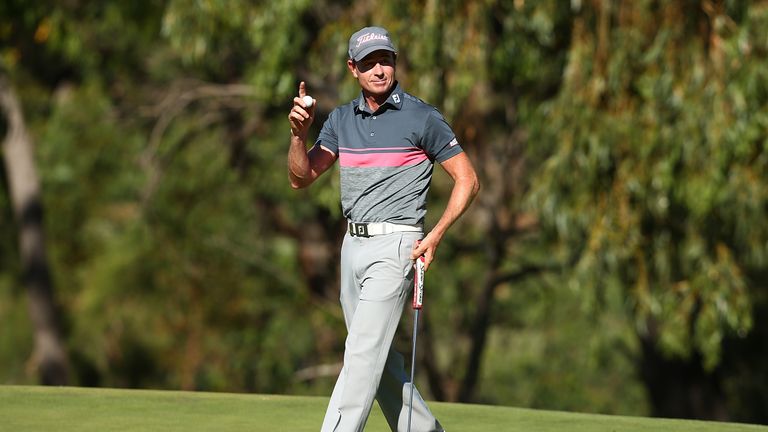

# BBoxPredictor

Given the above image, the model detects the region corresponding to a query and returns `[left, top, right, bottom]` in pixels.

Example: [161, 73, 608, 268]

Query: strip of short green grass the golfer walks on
[0, 386, 768, 432]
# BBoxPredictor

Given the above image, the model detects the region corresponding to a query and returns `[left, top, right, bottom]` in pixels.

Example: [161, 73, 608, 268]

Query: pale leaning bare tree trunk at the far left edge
[0, 74, 68, 385]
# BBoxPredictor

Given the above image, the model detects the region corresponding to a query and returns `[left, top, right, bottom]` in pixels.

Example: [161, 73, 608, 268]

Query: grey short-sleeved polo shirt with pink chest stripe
[315, 82, 463, 224]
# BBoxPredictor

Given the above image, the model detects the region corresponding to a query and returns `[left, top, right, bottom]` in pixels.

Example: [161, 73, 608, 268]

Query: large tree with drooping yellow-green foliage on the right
[531, 2, 768, 419]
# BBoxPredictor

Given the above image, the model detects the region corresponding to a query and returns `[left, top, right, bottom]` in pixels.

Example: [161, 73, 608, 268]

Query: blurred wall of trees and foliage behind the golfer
[0, 0, 768, 423]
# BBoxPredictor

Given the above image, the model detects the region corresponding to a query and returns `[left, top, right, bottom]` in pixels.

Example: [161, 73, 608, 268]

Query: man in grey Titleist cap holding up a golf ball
[288, 27, 479, 432]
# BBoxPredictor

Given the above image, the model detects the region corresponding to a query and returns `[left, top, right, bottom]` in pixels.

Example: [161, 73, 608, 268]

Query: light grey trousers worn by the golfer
[321, 232, 443, 432]
